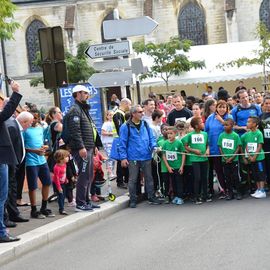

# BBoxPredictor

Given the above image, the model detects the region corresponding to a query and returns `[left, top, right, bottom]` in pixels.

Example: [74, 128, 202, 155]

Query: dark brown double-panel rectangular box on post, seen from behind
[38, 26, 68, 89]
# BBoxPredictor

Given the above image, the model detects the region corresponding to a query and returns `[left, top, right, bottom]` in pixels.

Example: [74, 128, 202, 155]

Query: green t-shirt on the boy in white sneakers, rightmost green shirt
[241, 129, 264, 161]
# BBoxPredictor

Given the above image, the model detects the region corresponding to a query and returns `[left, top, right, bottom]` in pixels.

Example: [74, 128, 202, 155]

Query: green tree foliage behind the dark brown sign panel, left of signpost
[30, 41, 95, 87]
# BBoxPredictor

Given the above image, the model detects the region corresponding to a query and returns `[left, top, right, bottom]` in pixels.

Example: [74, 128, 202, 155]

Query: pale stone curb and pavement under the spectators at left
[0, 181, 129, 265]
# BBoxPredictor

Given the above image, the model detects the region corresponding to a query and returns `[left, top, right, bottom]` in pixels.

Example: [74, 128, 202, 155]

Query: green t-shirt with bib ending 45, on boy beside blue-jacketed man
[162, 140, 185, 169]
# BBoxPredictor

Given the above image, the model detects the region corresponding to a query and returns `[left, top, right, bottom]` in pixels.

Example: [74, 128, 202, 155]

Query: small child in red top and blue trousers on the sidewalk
[53, 149, 69, 215]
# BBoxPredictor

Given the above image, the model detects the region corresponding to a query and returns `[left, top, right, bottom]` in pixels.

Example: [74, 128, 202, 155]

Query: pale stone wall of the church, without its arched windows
[0, 0, 261, 107]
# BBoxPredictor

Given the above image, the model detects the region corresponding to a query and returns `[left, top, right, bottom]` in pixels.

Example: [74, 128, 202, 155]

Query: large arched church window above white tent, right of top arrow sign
[178, 3, 207, 45]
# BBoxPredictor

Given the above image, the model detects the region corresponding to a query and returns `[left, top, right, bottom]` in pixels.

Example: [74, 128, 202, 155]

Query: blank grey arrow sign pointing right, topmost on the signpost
[103, 16, 158, 39]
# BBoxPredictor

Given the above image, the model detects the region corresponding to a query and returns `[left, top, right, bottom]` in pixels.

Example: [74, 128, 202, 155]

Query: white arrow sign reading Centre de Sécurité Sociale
[85, 40, 132, 59]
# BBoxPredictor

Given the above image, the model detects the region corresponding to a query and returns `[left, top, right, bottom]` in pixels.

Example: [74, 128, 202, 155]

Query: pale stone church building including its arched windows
[0, 0, 270, 108]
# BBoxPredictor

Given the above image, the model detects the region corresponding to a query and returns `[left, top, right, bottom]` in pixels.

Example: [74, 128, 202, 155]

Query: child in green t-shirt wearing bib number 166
[184, 117, 212, 204]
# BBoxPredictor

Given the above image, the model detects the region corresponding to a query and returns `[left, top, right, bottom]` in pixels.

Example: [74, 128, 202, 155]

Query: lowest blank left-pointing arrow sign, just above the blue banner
[88, 70, 133, 88]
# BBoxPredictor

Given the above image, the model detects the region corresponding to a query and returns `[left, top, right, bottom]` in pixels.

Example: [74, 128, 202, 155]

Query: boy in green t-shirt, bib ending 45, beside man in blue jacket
[162, 127, 186, 205]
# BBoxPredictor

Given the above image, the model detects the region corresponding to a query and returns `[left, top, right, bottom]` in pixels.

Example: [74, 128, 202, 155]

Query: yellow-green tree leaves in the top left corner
[0, 0, 20, 40]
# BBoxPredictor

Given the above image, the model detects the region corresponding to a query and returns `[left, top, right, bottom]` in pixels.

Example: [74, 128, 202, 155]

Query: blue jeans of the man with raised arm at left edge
[0, 164, 8, 237]
